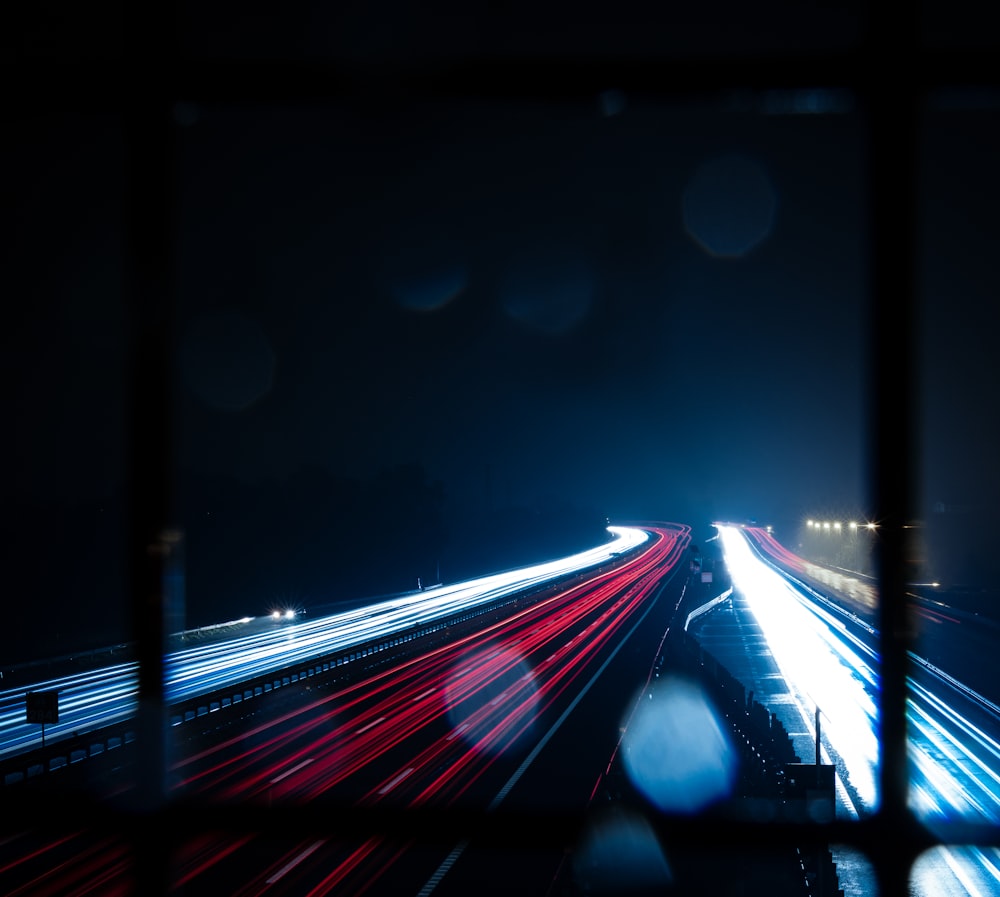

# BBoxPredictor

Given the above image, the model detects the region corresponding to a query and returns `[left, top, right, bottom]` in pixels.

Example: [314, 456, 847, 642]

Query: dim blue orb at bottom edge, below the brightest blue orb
[573, 810, 673, 895]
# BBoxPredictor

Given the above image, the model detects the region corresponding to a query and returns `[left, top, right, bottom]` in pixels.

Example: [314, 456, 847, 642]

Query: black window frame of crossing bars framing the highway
[5, 3, 1000, 897]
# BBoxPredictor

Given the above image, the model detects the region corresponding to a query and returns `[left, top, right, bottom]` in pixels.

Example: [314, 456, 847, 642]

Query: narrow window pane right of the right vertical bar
[909, 90, 1000, 836]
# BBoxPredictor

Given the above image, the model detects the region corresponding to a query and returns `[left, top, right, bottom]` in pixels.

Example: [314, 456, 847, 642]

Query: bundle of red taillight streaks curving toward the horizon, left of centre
[168, 530, 688, 895]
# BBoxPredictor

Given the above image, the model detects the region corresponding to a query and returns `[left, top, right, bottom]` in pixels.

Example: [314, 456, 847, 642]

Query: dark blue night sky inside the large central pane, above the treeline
[168, 97, 865, 516]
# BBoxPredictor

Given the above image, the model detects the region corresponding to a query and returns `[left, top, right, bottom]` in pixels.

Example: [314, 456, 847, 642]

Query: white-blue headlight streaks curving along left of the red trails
[0, 526, 649, 756]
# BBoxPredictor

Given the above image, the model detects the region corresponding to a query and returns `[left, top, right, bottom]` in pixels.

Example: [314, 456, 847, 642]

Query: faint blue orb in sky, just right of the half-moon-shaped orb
[500, 250, 594, 335]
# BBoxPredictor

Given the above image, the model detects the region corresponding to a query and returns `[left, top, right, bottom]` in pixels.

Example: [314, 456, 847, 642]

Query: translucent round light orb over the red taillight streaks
[444, 645, 539, 755]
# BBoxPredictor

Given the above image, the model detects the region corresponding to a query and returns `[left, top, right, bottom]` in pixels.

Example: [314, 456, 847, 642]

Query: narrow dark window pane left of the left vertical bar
[0, 110, 135, 792]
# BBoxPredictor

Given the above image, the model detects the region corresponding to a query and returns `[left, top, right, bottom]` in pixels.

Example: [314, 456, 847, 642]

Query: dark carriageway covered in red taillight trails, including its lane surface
[0, 525, 690, 897]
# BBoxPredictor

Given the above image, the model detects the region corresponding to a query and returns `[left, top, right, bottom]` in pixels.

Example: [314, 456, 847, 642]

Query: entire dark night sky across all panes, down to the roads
[0, 4, 1000, 653]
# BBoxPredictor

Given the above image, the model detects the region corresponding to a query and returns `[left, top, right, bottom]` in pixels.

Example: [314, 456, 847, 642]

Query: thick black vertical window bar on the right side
[866, 2, 917, 897]
